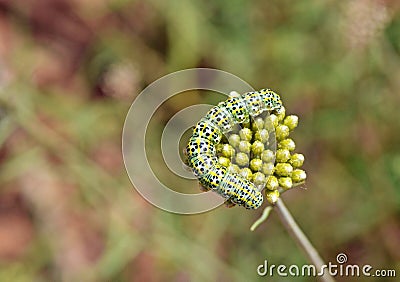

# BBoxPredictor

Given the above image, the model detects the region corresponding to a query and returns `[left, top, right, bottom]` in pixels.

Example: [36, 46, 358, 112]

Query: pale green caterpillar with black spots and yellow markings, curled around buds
[186, 89, 283, 209]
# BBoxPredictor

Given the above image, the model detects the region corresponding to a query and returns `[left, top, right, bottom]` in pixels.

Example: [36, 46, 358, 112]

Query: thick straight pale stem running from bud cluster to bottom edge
[275, 198, 335, 282]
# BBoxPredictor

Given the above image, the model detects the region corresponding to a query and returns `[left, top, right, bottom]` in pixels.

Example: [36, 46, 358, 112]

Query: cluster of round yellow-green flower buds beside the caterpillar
[216, 110, 307, 204]
